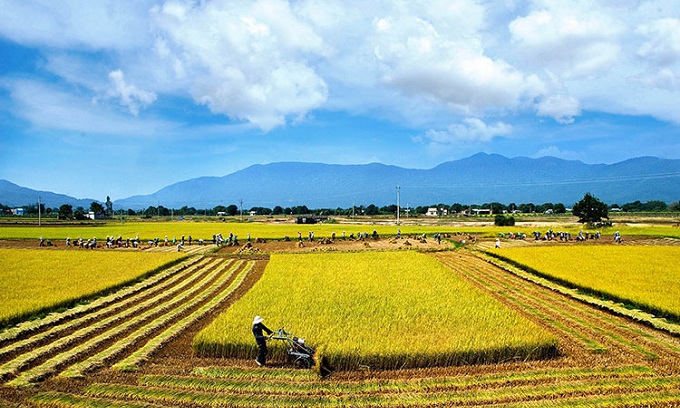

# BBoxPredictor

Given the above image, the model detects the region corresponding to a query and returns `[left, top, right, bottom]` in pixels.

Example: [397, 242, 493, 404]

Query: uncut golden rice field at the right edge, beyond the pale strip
[498, 246, 680, 320]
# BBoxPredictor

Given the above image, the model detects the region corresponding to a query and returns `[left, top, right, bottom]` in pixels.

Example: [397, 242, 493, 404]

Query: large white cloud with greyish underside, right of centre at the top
[370, 1, 542, 114]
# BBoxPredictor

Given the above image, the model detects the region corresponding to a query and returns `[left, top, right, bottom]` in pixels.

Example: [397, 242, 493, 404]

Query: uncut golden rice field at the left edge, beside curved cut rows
[0, 249, 184, 326]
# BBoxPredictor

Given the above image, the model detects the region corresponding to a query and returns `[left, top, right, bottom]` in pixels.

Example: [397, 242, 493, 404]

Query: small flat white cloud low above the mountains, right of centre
[418, 118, 512, 145]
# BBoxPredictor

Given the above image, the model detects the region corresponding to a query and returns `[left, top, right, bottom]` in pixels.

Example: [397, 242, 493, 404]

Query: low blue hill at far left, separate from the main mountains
[0, 180, 97, 209]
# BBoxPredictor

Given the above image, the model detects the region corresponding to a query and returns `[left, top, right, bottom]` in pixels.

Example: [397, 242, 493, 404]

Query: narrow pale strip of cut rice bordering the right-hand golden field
[474, 252, 680, 337]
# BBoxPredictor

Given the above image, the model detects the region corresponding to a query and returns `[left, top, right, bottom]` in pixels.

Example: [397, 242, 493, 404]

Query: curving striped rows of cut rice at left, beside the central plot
[0, 256, 254, 388]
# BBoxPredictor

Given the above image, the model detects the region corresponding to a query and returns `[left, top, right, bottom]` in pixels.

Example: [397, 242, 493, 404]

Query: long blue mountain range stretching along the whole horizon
[0, 153, 680, 210]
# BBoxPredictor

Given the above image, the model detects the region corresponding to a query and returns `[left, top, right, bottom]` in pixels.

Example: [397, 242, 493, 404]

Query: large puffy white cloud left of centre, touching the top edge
[152, 0, 328, 130]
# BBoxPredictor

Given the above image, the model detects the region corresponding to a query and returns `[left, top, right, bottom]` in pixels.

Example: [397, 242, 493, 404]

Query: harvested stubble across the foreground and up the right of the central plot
[6, 251, 680, 408]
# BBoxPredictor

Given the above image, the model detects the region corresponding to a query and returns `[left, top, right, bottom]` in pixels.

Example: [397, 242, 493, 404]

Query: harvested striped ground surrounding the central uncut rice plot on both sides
[0, 240, 680, 407]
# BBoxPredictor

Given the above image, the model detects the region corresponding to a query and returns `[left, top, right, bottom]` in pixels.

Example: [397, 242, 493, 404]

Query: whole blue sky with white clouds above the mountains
[0, 0, 680, 200]
